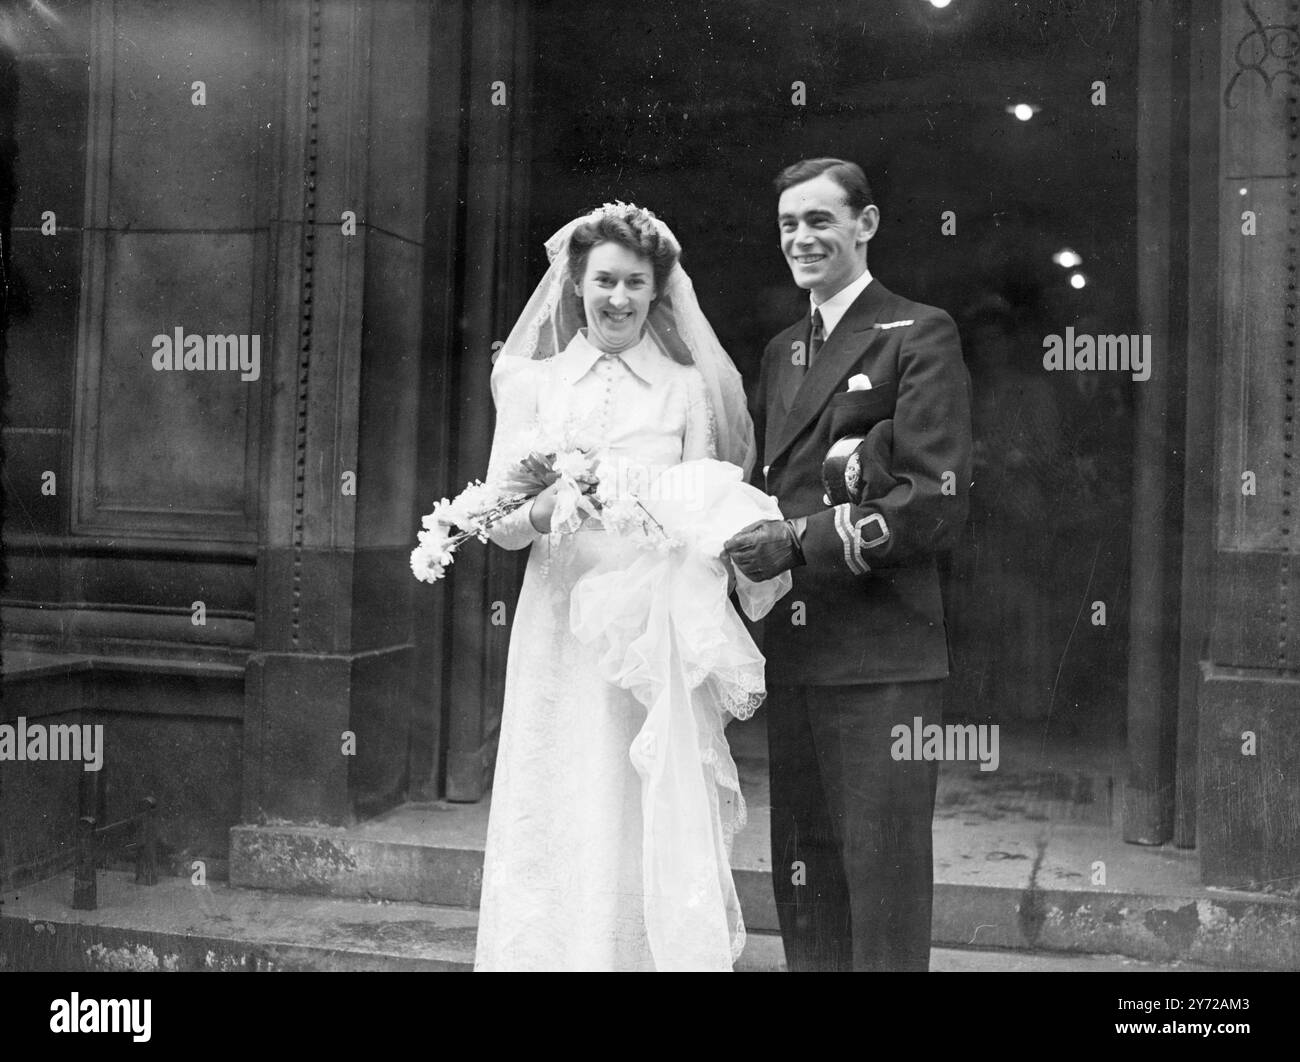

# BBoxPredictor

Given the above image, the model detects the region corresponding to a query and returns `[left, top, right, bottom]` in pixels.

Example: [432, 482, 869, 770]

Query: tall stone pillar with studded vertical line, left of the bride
[243, 0, 433, 824]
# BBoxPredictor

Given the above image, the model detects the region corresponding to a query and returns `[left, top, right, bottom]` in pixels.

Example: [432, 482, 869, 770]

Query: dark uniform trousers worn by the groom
[764, 680, 944, 971]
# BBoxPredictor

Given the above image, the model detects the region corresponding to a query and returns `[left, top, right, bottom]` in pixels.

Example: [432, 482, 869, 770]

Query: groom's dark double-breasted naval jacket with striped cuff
[751, 279, 971, 686]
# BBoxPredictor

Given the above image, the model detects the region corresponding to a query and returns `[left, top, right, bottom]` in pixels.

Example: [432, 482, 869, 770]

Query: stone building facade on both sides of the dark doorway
[0, 0, 1300, 887]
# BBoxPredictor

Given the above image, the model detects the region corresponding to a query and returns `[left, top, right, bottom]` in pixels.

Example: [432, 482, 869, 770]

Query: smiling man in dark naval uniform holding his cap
[727, 159, 971, 970]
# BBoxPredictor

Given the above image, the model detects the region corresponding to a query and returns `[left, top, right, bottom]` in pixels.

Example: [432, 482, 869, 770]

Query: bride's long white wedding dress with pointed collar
[475, 333, 780, 971]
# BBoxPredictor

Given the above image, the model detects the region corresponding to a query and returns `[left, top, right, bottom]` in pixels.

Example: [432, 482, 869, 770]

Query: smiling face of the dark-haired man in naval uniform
[776, 174, 880, 303]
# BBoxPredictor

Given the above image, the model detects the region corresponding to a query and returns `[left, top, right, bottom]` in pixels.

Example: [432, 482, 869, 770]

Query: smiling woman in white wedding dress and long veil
[475, 203, 788, 971]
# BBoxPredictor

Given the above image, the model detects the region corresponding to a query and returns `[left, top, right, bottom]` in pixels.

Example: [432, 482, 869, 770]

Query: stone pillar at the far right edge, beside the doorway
[1197, 0, 1300, 887]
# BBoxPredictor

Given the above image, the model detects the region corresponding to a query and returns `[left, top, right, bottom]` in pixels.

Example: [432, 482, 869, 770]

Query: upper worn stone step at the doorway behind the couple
[230, 802, 1300, 970]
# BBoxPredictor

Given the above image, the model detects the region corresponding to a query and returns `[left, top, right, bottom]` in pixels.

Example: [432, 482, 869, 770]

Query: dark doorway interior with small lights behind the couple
[529, 0, 1138, 740]
